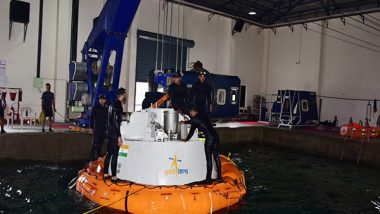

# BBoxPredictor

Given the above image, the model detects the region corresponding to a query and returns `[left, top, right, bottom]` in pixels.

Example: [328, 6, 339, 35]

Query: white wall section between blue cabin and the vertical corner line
[263, 27, 320, 93]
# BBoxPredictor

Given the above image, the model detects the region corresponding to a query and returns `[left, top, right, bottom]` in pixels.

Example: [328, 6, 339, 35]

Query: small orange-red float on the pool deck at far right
[339, 123, 380, 138]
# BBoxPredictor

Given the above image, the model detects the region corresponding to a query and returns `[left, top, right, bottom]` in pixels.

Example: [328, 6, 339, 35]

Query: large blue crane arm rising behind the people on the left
[69, 0, 140, 127]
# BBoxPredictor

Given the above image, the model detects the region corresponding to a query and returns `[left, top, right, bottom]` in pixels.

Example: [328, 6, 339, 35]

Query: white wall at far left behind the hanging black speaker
[0, 0, 40, 109]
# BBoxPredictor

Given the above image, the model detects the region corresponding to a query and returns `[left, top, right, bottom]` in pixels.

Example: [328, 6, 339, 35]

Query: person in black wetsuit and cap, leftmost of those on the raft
[90, 94, 108, 161]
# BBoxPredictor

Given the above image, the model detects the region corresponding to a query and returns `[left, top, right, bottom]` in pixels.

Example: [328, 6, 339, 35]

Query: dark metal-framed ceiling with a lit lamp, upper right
[168, 0, 380, 28]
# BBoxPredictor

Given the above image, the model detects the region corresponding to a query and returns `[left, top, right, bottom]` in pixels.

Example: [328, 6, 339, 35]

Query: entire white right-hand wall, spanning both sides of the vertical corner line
[262, 16, 380, 125]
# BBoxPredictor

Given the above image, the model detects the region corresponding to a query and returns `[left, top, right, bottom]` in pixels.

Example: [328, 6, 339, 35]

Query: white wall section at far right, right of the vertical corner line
[321, 18, 380, 125]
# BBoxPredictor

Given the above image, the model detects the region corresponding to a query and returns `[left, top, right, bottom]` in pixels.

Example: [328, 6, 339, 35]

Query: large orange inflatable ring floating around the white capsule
[76, 155, 246, 214]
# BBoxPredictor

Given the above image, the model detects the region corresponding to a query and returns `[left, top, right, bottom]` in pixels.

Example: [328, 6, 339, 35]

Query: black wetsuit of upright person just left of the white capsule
[104, 100, 123, 176]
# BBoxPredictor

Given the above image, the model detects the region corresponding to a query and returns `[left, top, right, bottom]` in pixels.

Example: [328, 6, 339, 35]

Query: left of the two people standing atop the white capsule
[168, 73, 190, 114]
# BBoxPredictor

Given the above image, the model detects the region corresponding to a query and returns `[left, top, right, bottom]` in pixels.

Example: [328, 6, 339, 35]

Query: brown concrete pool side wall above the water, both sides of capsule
[0, 126, 380, 166]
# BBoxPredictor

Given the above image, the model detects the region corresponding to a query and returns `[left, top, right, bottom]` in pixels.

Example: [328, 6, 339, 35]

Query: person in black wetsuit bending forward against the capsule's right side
[180, 107, 222, 182]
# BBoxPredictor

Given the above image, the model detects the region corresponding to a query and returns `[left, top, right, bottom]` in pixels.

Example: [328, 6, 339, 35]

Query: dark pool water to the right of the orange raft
[223, 146, 380, 213]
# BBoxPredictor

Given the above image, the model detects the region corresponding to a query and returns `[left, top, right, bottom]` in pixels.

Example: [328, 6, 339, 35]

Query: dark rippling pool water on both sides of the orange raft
[0, 144, 380, 214]
